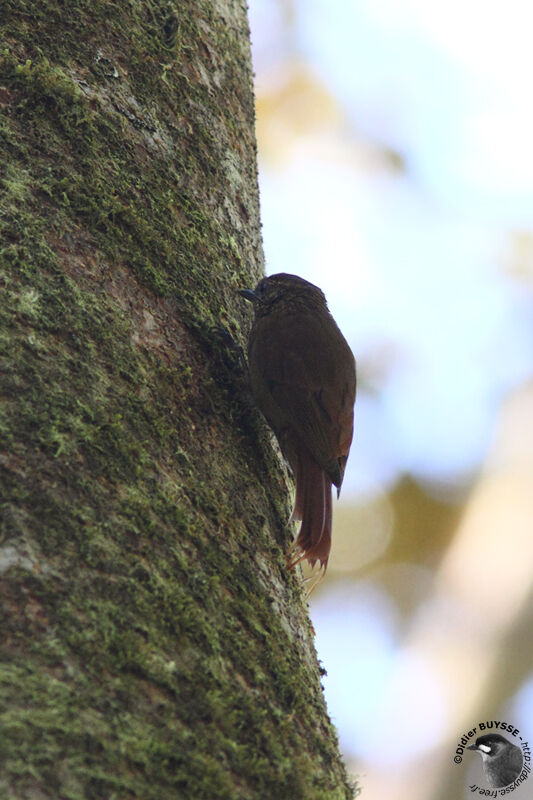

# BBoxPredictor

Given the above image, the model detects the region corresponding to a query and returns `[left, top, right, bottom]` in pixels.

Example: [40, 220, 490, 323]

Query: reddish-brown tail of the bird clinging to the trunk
[289, 448, 332, 572]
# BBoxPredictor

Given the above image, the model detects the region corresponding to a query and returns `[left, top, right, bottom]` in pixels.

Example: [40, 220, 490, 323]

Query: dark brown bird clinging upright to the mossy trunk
[240, 273, 355, 572]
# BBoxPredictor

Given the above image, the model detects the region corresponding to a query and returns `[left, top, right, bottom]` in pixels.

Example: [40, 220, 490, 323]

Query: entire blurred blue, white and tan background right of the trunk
[250, 0, 533, 800]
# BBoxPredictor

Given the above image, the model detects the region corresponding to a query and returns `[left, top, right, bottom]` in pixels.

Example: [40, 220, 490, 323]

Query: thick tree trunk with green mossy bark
[0, 0, 351, 800]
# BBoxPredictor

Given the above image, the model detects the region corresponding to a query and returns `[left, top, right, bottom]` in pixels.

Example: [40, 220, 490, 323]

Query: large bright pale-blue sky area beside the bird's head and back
[250, 0, 533, 493]
